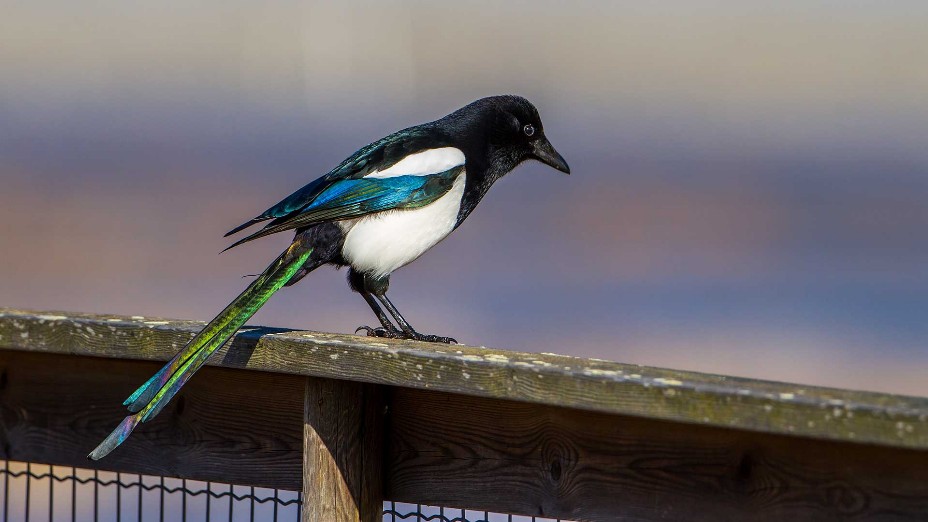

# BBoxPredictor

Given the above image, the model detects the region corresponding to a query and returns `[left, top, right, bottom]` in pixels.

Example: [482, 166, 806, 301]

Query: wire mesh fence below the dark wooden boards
[0, 460, 566, 522]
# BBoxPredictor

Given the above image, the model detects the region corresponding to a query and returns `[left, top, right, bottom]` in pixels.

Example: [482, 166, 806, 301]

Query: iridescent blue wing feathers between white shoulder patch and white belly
[223, 166, 464, 252]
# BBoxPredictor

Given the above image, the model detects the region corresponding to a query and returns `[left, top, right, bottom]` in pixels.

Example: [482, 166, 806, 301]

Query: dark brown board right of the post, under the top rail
[385, 388, 928, 521]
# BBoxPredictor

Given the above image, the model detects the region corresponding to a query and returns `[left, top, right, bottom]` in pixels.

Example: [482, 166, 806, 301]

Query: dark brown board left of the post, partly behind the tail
[0, 351, 304, 490]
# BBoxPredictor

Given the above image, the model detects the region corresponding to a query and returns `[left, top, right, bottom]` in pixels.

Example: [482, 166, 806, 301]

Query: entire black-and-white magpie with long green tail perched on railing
[88, 95, 570, 460]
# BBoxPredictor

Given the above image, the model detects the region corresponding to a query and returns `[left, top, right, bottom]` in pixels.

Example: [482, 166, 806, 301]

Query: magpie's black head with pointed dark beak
[443, 95, 570, 175]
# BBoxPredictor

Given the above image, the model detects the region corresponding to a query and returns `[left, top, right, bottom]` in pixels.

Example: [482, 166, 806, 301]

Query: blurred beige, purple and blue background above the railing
[0, 0, 928, 395]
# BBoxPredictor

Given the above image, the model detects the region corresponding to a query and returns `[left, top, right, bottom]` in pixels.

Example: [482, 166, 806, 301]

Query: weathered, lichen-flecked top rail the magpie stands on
[0, 309, 928, 449]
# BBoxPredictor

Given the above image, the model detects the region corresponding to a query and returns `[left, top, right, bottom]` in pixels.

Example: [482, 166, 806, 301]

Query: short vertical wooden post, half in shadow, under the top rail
[303, 377, 384, 522]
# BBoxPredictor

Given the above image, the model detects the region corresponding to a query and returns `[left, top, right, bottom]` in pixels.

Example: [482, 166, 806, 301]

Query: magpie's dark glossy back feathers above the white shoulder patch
[225, 124, 436, 237]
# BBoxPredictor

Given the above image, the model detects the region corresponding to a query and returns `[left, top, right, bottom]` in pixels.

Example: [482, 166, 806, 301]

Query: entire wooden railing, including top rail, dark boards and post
[0, 309, 928, 521]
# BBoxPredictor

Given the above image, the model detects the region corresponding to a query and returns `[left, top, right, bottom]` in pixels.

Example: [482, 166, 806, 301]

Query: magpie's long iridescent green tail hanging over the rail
[88, 241, 312, 460]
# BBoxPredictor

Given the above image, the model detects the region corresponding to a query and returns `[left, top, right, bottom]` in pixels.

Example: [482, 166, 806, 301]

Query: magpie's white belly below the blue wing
[341, 173, 466, 277]
